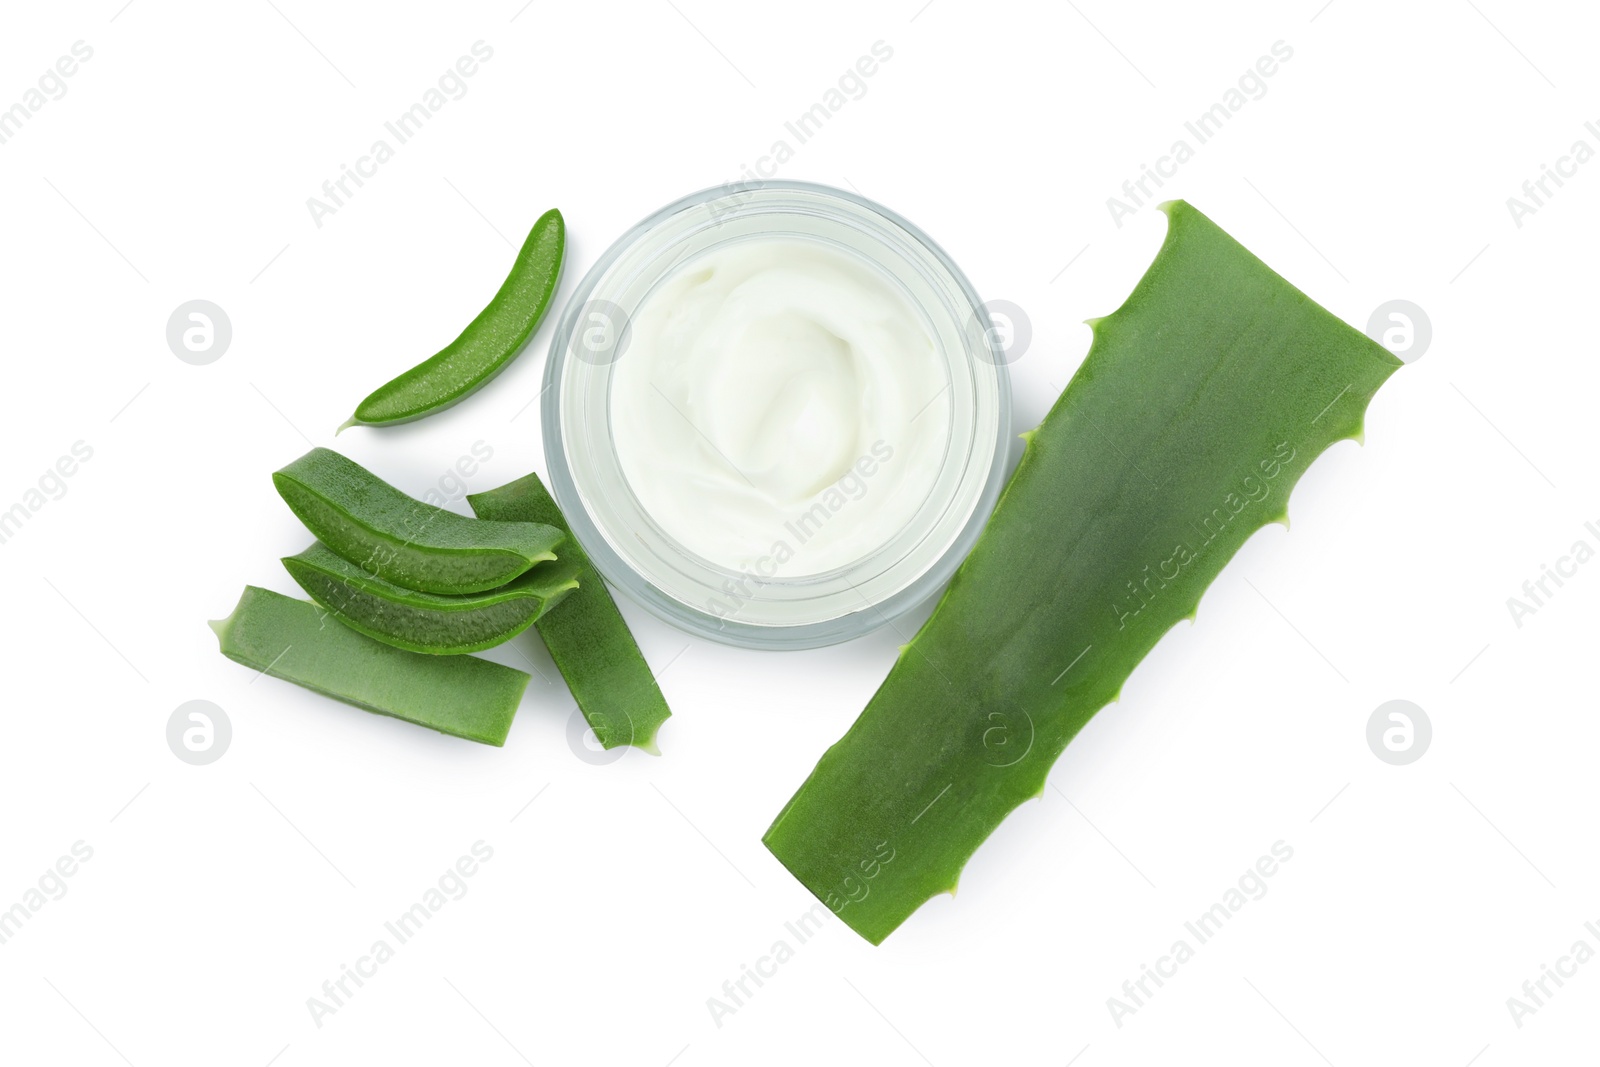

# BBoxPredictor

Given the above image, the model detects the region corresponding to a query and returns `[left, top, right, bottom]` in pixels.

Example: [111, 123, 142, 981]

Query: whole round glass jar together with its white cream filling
[542, 182, 1010, 648]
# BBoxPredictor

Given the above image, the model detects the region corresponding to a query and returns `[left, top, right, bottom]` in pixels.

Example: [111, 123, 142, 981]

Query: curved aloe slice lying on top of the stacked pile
[272, 448, 565, 595]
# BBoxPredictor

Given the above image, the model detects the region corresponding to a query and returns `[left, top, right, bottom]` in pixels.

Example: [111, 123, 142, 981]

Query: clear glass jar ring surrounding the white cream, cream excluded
[542, 181, 1011, 648]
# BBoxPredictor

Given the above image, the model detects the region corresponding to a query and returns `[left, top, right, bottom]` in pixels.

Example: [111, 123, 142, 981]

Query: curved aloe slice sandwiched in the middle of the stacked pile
[283, 541, 578, 656]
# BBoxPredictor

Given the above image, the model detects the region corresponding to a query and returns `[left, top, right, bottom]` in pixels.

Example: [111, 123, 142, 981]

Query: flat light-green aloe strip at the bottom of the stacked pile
[211, 585, 528, 745]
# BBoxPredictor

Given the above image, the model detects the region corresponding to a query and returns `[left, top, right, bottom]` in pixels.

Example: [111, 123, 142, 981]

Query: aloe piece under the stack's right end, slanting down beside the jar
[467, 474, 672, 753]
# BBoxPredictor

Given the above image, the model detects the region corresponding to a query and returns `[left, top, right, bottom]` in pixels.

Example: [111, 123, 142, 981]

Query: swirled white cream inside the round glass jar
[610, 237, 950, 579]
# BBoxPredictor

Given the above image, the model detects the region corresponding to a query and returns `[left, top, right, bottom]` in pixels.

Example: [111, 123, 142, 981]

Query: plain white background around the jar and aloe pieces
[0, 0, 1600, 1067]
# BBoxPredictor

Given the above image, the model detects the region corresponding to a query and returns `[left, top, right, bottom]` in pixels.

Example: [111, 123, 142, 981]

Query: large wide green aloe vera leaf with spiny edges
[763, 202, 1400, 944]
